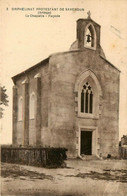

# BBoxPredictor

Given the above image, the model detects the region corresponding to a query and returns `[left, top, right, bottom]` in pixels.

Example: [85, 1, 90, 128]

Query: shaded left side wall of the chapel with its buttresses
[13, 63, 50, 145]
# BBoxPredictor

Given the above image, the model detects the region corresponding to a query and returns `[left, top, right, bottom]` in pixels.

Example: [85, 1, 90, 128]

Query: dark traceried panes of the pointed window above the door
[81, 82, 93, 113]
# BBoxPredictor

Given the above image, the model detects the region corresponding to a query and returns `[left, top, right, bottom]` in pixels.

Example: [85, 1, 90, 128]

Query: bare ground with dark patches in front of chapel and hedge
[1, 160, 127, 196]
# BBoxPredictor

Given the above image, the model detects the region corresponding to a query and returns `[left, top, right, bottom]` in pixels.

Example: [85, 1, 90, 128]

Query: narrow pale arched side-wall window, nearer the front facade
[30, 93, 35, 119]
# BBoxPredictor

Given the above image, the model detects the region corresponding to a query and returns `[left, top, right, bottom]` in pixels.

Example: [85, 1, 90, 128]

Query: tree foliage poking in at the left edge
[0, 86, 9, 118]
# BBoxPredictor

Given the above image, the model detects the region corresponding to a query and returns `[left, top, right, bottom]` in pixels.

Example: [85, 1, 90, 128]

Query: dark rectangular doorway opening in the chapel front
[80, 131, 92, 155]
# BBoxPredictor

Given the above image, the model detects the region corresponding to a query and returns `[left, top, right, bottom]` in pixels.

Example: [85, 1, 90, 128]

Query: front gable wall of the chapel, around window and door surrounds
[49, 49, 119, 156]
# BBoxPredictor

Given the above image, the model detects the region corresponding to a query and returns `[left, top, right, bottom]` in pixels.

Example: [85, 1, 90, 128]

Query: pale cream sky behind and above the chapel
[0, 0, 127, 144]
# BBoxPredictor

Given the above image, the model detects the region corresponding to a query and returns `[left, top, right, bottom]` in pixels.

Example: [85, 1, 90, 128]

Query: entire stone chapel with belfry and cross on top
[12, 15, 120, 157]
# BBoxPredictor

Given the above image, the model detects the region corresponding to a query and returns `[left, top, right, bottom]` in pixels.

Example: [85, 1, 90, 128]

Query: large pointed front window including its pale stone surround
[74, 70, 102, 119]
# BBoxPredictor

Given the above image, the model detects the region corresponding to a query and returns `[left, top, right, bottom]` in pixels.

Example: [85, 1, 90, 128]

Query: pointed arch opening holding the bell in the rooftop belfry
[84, 24, 96, 48]
